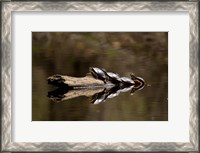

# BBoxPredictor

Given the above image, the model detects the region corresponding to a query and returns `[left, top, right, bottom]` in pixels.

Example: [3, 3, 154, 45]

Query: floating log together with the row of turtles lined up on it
[48, 67, 145, 89]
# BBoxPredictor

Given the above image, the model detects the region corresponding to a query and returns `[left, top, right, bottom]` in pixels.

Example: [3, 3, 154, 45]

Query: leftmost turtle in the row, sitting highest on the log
[89, 67, 108, 83]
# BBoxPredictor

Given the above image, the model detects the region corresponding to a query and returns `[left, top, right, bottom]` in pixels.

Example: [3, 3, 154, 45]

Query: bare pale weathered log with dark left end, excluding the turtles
[48, 74, 105, 87]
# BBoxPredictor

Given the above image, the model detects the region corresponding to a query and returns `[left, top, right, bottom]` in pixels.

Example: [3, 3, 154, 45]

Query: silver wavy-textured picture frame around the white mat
[1, 1, 199, 152]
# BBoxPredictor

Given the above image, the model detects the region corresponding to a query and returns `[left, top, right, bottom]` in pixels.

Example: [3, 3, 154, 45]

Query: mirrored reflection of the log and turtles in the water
[48, 82, 144, 104]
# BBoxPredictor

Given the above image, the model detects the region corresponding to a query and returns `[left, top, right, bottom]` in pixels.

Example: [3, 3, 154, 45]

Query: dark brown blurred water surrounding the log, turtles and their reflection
[32, 32, 168, 121]
